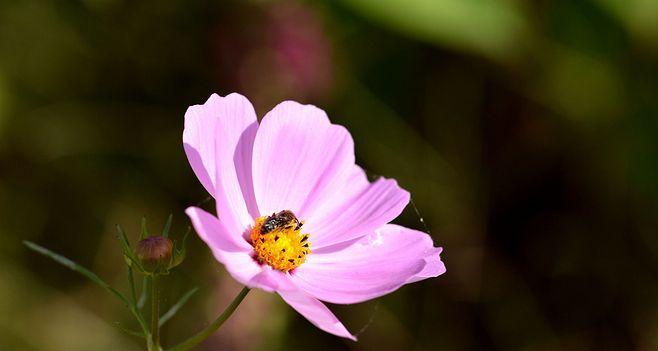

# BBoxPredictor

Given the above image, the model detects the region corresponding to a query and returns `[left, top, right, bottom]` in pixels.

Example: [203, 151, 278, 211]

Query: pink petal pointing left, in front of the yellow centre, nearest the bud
[185, 207, 292, 291]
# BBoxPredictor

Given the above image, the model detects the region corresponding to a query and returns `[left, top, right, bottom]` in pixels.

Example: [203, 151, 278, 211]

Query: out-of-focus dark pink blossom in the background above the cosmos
[213, 1, 334, 107]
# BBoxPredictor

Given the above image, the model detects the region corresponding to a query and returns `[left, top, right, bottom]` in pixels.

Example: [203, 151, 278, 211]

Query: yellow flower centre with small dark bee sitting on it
[251, 210, 311, 272]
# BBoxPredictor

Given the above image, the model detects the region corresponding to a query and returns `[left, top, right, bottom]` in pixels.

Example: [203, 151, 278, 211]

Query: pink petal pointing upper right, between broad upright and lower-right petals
[305, 178, 409, 250]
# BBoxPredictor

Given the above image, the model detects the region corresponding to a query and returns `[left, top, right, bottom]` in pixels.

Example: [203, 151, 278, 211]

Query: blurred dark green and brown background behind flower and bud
[0, 0, 658, 351]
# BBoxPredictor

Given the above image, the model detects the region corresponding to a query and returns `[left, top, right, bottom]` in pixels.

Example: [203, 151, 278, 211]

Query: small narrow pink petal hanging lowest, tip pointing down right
[278, 290, 356, 341]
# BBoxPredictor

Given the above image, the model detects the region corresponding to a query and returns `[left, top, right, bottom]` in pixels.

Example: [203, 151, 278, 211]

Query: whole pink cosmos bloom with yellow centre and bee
[183, 94, 445, 340]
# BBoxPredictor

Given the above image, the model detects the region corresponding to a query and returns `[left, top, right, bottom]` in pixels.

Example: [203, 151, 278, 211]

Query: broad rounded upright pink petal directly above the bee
[253, 101, 354, 220]
